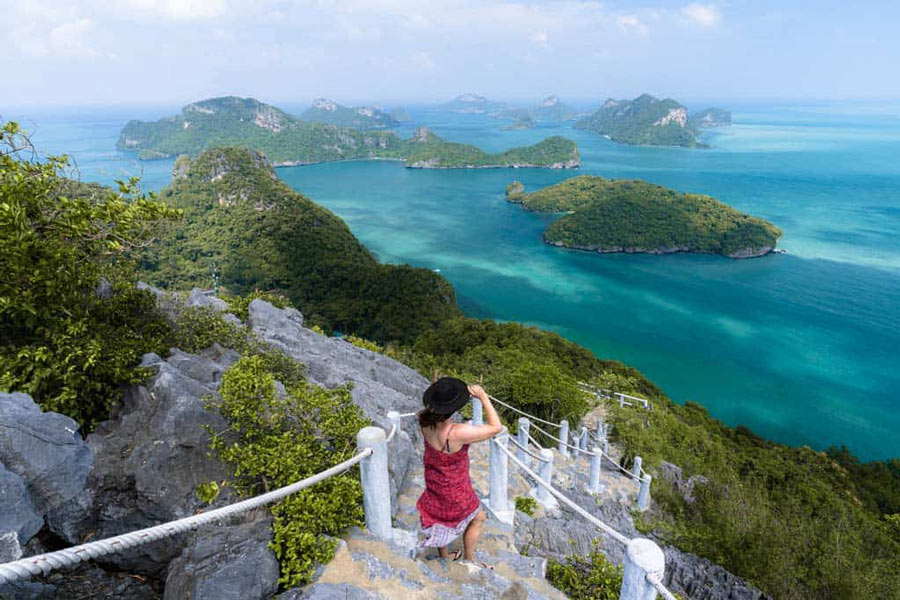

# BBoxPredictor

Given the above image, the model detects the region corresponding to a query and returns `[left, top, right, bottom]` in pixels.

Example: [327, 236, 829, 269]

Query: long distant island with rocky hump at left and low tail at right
[116, 96, 580, 169]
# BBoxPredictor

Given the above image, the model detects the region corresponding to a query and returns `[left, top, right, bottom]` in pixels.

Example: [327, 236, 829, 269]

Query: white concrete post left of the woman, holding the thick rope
[356, 427, 393, 541]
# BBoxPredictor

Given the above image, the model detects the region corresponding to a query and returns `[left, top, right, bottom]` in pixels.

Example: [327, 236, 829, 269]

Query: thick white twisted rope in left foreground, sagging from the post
[0, 448, 373, 584]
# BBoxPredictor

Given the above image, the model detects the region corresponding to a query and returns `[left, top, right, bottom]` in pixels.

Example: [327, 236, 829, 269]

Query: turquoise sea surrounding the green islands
[3, 103, 900, 459]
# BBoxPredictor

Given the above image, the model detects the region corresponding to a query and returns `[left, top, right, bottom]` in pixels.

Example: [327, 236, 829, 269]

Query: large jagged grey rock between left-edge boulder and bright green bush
[47, 347, 238, 577]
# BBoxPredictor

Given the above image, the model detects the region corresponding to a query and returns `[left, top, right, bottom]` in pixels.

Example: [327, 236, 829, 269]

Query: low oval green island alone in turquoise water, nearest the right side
[506, 175, 782, 258]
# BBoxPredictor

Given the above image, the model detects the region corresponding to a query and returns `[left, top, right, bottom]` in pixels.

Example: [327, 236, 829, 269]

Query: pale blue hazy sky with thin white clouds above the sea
[0, 0, 900, 107]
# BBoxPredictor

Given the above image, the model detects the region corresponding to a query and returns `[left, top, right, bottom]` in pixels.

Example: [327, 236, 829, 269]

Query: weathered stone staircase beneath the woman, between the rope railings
[298, 414, 637, 600]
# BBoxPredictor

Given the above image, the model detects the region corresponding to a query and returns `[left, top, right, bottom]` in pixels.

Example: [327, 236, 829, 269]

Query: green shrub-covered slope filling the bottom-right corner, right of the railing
[607, 398, 900, 599]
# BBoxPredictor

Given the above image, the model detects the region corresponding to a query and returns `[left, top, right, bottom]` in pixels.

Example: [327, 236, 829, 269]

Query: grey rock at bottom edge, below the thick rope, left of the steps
[165, 509, 278, 600]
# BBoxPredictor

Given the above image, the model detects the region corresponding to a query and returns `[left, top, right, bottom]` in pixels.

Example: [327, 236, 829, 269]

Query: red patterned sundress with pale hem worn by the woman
[416, 424, 481, 546]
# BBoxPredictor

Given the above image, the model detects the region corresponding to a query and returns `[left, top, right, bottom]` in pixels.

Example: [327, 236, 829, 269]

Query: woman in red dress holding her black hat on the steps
[416, 377, 503, 569]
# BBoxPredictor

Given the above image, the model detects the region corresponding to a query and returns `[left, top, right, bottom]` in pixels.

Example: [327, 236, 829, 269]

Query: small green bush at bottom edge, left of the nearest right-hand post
[547, 547, 622, 600]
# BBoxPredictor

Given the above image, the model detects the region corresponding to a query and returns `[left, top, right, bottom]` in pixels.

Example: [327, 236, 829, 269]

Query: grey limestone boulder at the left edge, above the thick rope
[0, 393, 94, 516]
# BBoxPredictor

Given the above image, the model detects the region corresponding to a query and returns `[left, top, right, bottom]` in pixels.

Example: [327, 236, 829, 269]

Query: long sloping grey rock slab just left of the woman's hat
[249, 298, 428, 507]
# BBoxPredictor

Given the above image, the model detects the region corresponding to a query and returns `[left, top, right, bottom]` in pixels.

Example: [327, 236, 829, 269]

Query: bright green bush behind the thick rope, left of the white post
[211, 356, 368, 587]
